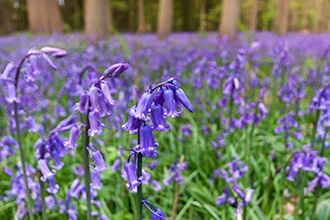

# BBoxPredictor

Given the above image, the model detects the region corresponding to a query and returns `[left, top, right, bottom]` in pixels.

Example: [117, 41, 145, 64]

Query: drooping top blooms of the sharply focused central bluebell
[123, 79, 194, 161]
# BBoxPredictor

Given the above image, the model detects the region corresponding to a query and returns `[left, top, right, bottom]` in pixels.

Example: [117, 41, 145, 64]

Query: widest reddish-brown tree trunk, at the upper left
[27, 0, 63, 33]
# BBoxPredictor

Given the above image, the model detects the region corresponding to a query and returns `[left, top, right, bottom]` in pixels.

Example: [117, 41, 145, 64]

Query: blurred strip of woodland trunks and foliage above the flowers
[0, 0, 330, 39]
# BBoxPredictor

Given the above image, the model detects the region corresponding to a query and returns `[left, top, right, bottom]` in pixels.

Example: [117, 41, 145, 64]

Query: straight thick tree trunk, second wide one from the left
[85, 0, 111, 41]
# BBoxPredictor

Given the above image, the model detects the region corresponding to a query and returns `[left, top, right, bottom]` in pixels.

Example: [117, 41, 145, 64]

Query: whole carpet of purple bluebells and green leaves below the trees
[0, 32, 330, 220]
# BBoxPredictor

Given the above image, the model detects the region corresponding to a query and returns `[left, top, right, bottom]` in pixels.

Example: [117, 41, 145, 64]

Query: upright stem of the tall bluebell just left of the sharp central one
[83, 108, 92, 220]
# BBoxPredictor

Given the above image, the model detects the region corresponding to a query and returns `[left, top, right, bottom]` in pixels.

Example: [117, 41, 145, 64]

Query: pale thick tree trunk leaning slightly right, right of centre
[218, 0, 241, 40]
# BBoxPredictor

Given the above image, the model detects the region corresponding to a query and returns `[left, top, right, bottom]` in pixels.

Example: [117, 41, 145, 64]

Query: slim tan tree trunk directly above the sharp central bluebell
[157, 0, 173, 40]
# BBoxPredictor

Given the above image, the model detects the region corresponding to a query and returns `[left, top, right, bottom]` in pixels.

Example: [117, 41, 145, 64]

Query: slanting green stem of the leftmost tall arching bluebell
[14, 102, 34, 220]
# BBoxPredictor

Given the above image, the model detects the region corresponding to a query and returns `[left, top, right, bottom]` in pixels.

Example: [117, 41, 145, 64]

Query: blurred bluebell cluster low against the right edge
[286, 145, 330, 192]
